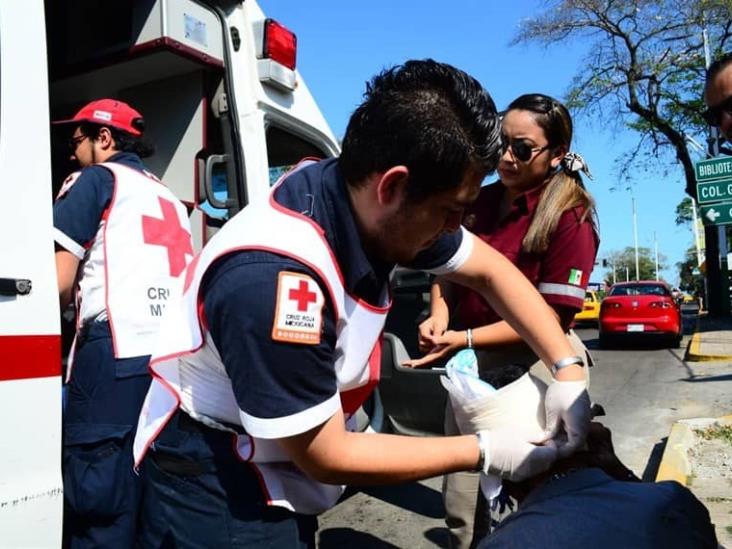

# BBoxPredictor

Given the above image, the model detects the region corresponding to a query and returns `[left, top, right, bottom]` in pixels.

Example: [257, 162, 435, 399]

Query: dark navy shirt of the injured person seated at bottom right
[479, 469, 717, 549]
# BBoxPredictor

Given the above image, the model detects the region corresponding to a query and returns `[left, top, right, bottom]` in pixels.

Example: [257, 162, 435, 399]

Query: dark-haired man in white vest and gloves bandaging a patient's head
[135, 60, 589, 547]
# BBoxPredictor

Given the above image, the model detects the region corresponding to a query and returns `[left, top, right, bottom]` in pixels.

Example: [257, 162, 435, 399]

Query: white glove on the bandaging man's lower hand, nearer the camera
[481, 429, 557, 481]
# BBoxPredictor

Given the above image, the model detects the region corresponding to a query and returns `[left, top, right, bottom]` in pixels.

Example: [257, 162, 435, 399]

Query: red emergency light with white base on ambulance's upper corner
[254, 19, 297, 91]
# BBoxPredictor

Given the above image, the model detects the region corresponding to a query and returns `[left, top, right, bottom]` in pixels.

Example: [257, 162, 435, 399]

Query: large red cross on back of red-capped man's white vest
[142, 196, 193, 277]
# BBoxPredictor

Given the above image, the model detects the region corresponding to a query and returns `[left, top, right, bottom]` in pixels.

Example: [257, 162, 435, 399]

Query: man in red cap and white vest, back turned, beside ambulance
[53, 99, 193, 548]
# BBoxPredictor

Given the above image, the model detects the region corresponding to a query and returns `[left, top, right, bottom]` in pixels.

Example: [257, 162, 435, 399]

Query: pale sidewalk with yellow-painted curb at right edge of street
[656, 315, 732, 547]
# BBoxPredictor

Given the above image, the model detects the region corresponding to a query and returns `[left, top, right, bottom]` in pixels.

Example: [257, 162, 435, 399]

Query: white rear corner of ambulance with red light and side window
[200, 0, 340, 218]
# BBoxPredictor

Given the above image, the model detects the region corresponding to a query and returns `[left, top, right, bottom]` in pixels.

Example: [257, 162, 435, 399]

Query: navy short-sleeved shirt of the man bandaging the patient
[201, 159, 462, 436]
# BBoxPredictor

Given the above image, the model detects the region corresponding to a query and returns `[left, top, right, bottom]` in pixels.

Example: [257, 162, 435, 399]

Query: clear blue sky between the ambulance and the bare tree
[259, 0, 693, 283]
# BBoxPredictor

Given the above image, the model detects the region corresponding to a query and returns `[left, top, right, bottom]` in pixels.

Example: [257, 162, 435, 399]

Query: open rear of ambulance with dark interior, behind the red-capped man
[46, 0, 339, 253]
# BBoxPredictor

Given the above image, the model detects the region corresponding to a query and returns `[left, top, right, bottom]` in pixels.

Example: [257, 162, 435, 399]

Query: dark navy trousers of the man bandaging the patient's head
[140, 411, 318, 549]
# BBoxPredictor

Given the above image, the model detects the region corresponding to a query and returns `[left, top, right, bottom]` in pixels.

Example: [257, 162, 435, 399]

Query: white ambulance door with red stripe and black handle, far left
[0, 0, 63, 547]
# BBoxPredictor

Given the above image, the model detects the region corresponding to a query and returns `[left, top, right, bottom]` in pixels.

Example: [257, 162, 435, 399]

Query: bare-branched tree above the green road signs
[514, 0, 732, 196]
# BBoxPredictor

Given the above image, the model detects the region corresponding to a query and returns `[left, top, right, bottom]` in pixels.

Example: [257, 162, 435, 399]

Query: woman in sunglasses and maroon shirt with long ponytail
[406, 94, 599, 547]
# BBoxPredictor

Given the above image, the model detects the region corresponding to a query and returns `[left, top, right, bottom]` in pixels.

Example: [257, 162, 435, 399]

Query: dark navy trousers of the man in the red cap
[63, 322, 150, 549]
